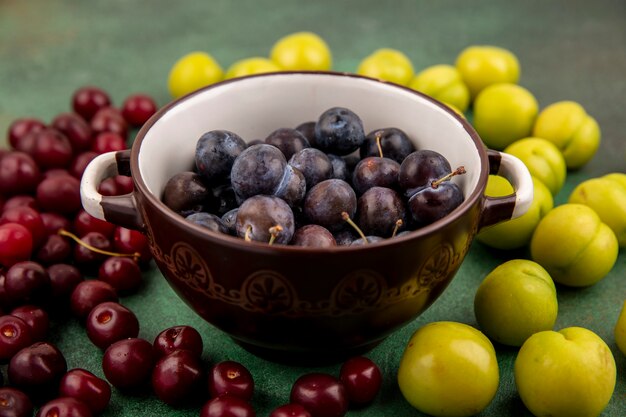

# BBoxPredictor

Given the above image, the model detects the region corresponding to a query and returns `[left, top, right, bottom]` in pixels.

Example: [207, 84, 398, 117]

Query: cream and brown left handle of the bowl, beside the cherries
[80, 149, 144, 230]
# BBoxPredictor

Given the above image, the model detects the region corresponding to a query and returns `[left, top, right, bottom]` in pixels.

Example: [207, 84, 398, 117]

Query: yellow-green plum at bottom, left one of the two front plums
[398, 321, 500, 417]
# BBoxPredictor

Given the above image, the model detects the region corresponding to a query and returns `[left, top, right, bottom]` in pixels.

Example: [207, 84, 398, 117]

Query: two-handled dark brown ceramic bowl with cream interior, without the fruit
[81, 72, 532, 360]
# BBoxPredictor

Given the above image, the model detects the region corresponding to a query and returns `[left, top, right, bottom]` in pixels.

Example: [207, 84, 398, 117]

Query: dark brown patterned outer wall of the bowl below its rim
[139, 187, 480, 359]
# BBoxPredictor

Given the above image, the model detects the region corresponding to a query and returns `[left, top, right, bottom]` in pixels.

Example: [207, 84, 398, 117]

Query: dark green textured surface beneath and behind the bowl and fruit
[0, 0, 626, 417]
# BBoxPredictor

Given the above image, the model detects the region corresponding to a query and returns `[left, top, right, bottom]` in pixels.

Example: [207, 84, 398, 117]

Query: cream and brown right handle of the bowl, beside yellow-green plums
[478, 150, 533, 230]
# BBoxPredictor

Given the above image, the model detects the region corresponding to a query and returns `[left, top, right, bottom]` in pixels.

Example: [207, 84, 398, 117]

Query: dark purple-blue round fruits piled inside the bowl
[162, 107, 465, 247]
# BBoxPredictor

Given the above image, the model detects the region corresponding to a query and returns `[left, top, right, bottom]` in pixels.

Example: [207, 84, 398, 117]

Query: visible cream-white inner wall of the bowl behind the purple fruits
[138, 73, 480, 197]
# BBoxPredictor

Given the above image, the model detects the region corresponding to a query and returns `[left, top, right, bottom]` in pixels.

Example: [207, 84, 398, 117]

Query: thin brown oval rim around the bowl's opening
[130, 71, 489, 254]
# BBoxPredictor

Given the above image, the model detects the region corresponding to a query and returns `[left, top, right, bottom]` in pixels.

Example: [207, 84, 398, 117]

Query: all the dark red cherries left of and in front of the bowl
[0, 87, 390, 417]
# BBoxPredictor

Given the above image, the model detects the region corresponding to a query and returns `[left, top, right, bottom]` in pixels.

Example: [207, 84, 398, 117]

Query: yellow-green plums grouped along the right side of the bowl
[376, 46, 626, 416]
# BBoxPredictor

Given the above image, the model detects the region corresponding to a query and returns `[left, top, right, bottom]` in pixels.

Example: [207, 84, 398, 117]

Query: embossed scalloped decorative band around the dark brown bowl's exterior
[147, 236, 460, 317]
